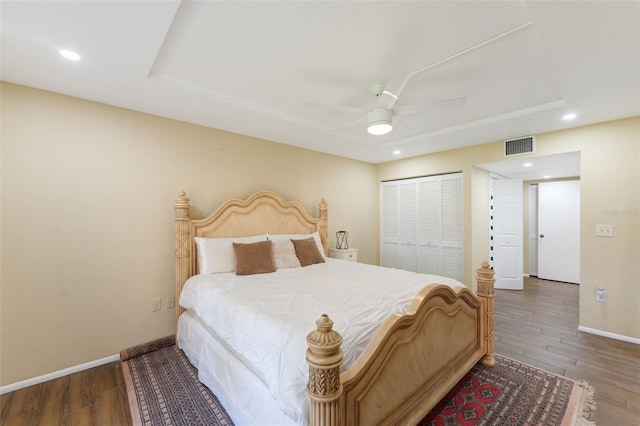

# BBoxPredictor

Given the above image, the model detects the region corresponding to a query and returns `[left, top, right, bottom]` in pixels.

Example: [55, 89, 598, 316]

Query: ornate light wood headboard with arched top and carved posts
[173, 191, 328, 316]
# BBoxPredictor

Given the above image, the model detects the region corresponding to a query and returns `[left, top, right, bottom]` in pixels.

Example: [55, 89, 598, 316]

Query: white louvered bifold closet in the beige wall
[380, 173, 463, 280]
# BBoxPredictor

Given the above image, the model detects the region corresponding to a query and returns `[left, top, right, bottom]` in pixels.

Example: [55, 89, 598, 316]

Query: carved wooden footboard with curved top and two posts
[307, 262, 495, 426]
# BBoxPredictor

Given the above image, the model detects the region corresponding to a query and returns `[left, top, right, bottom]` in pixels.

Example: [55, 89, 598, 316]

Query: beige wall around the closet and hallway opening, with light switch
[377, 117, 640, 339]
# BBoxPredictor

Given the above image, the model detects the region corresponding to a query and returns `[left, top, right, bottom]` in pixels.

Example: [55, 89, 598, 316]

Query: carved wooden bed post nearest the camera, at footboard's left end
[307, 314, 342, 426]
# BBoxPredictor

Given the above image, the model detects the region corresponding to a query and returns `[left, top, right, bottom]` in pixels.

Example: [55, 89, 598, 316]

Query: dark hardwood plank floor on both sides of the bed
[0, 278, 640, 426]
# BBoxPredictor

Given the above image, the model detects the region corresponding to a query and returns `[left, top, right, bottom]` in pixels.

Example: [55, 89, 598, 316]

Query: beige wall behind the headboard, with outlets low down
[0, 83, 378, 385]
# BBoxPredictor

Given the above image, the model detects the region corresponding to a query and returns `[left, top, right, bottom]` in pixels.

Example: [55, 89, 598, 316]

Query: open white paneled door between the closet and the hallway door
[491, 179, 524, 290]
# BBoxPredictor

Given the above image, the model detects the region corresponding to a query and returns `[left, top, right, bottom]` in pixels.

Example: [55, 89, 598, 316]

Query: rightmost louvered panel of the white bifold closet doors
[438, 173, 463, 281]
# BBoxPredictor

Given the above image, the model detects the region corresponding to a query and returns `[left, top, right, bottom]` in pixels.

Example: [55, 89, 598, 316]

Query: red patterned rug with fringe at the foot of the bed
[419, 355, 595, 426]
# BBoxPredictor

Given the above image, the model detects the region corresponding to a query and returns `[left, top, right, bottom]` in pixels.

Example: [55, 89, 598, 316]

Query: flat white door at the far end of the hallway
[538, 180, 580, 283]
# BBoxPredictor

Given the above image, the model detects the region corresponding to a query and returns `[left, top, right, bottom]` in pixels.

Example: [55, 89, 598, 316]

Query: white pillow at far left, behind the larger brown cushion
[194, 234, 267, 274]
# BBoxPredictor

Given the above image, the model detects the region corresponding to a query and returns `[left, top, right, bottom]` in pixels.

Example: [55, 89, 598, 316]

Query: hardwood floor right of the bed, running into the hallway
[495, 278, 640, 426]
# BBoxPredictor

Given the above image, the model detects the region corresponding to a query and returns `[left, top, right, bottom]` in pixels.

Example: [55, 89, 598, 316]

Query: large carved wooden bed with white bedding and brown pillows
[174, 191, 495, 426]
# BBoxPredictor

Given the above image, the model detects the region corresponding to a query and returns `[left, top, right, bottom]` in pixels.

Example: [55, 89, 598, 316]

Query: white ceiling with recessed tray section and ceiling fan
[0, 0, 640, 163]
